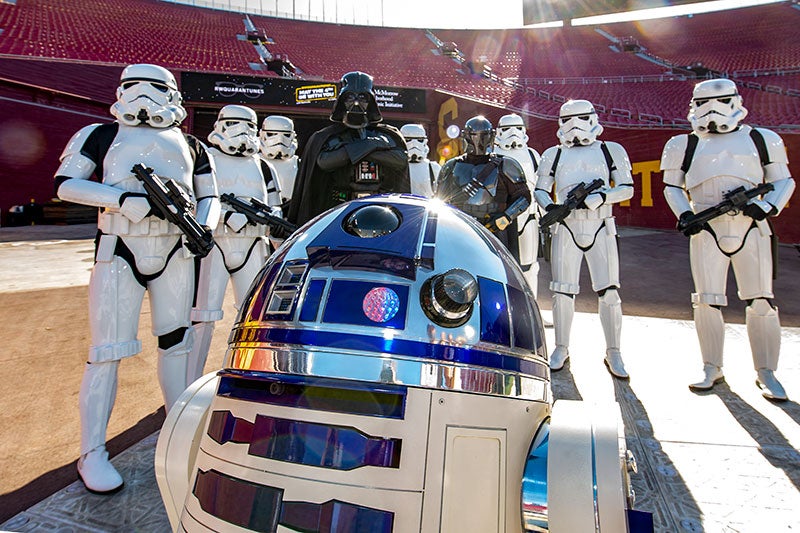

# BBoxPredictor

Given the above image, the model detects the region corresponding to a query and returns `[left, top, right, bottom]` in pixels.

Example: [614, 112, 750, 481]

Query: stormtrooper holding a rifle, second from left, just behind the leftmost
[188, 105, 281, 383]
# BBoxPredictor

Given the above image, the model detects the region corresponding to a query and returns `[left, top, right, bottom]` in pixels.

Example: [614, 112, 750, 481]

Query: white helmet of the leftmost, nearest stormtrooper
[111, 64, 186, 128]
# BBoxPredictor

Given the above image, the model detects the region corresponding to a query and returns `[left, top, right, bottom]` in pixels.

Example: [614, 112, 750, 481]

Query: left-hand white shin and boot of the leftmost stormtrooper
[78, 361, 123, 494]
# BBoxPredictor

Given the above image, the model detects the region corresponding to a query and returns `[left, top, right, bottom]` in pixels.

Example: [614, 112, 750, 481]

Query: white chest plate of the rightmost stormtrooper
[686, 130, 764, 190]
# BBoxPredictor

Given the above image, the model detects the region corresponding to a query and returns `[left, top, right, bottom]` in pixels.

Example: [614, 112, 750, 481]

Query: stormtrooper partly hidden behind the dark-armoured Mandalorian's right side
[493, 113, 539, 297]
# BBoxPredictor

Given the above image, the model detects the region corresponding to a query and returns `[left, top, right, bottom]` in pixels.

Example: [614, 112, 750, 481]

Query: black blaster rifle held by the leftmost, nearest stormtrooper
[131, 163, 214, 257]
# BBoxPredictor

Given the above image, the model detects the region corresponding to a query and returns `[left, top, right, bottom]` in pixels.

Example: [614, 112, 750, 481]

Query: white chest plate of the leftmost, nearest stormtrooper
[103, 124, 194, 197]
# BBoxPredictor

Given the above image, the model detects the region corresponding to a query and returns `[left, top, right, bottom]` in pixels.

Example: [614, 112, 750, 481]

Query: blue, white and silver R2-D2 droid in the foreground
[156, 195, 648, 533]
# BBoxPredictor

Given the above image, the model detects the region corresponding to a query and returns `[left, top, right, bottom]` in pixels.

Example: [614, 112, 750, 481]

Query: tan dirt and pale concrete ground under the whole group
[0, 222, 800, 533]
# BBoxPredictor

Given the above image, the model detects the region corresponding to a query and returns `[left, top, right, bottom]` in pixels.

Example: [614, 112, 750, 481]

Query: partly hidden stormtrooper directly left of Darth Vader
[258, 115, 300, 210]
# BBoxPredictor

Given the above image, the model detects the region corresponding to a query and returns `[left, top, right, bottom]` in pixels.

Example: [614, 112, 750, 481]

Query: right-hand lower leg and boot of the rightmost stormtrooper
[745, 298, 787, 401]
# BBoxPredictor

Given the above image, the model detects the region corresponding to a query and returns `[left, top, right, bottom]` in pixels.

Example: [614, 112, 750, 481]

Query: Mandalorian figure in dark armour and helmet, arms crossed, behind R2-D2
[436, 115, 531, 252]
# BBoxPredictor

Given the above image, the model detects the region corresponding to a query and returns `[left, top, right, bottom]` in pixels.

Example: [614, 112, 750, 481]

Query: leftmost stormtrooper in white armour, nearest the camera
[55, 64, 220, 493]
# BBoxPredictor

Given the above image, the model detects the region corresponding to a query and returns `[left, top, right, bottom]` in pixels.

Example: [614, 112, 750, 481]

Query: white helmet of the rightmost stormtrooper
[687, 79, 747, 134]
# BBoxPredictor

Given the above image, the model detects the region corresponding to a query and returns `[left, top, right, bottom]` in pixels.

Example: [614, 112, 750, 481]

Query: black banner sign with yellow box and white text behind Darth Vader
[181, 72, 426, 114]
